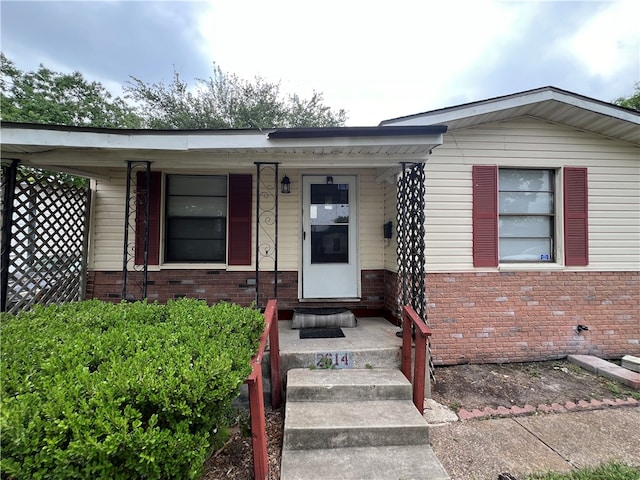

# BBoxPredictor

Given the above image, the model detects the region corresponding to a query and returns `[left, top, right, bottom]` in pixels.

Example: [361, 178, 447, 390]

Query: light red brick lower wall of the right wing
[387, 272, 640, 365]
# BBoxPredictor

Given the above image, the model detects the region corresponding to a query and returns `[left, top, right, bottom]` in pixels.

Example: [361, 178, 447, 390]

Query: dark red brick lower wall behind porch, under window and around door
[86, 270, 385, 318]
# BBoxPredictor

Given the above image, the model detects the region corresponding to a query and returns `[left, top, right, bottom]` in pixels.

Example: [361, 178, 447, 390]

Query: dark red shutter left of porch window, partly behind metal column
[135, 172, 162, 265]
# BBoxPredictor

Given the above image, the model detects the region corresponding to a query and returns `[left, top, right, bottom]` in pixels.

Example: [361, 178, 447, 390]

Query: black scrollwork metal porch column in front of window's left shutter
[122, 160, 151, 300]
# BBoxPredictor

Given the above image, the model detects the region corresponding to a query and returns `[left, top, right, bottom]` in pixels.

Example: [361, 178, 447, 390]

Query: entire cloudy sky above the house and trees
[0, 0, 640, 126]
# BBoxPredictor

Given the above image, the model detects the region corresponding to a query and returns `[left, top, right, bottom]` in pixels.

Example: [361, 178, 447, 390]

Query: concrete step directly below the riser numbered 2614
[287, 368, 412, 402]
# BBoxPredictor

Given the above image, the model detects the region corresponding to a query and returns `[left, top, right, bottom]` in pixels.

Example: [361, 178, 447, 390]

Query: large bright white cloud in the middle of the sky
[199, 0, 520, 125]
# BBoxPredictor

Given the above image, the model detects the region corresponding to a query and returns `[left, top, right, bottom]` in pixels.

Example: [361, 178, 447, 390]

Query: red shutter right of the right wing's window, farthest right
[564, 168, 589, 266]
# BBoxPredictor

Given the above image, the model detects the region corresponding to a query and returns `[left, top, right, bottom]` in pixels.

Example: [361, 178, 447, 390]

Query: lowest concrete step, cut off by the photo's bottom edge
[280, 445, 449, 480]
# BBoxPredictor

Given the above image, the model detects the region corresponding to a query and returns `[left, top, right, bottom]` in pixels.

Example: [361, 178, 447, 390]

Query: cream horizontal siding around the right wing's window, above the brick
[426, 118, 640, 272]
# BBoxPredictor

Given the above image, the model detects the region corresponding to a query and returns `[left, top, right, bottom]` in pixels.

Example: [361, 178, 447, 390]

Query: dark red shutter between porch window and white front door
[227, 175, 253, 265]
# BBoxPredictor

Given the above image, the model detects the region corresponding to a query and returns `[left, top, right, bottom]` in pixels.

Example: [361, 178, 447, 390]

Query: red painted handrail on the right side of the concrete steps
[402, 305, 431, 413]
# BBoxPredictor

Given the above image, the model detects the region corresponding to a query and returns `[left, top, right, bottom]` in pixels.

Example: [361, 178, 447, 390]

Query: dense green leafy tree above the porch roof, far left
[0, 53, 142, 128]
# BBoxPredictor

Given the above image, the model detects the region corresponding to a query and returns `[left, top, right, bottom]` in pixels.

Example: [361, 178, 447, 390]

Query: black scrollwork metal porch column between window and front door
[255, 162, 279, 309]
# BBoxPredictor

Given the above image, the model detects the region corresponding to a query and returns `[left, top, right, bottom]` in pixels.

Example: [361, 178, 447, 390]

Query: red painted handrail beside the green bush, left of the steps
[245, 300, 282, 480]
